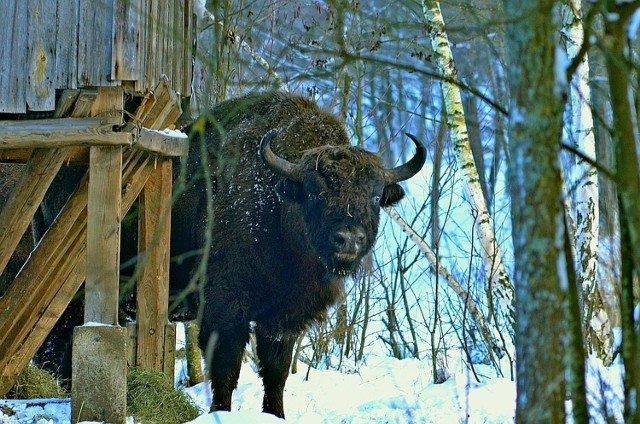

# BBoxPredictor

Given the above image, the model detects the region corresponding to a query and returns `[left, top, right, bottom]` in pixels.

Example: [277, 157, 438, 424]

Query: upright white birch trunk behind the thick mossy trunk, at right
[562, 0, 613, 364]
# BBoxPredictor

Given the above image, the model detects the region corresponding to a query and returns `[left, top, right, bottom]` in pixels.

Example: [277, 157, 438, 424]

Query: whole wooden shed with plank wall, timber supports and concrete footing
[0, 0, 196, 423]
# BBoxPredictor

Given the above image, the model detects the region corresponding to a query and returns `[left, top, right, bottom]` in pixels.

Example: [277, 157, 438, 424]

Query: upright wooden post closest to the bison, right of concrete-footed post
[136, 158, 172, 370]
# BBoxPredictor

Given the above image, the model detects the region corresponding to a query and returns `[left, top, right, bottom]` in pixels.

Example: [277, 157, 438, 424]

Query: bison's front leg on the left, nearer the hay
[200, 325, 249, 412]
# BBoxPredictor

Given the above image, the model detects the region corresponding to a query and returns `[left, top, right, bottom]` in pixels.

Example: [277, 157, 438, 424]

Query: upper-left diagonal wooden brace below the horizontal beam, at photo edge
[0, 148, 69, 274]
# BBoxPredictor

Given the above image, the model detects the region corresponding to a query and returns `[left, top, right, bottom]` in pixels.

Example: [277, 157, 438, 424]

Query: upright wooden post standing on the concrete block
[84, 147, 122, 325]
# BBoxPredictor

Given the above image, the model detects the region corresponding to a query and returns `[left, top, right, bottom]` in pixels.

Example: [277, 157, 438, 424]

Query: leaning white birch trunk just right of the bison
[422, 0, 515, 354]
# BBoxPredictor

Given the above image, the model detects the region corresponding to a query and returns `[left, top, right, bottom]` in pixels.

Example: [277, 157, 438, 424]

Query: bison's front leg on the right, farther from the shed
[256, 330, 296, 418]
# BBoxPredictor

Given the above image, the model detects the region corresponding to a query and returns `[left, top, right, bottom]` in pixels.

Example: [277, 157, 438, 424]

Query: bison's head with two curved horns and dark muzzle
[260, 130, 426, 276]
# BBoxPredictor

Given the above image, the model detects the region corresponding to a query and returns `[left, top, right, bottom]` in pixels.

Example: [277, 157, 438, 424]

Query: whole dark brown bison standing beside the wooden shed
[180, 92, 426, 417]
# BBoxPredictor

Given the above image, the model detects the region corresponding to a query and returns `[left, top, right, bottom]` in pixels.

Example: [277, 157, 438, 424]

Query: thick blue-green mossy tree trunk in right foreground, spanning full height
[503, 0, 569, 424]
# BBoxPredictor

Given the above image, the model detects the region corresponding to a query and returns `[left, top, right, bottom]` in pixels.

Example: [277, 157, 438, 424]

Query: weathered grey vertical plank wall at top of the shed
[0, 0, 196, 113]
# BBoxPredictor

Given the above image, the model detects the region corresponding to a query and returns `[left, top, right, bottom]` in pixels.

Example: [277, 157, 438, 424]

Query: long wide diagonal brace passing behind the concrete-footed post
[0, 151, 154, 396]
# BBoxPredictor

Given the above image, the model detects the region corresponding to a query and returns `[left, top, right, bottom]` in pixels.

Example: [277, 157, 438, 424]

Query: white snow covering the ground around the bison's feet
[0, 324, 623, 424]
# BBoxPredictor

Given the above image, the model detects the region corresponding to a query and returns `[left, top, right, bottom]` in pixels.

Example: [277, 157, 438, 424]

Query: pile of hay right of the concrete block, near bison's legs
[127, 368, 200, 424]
